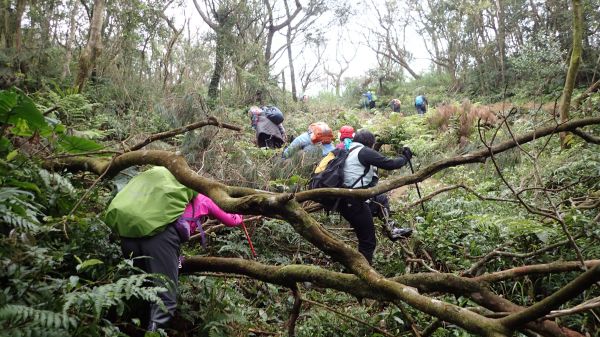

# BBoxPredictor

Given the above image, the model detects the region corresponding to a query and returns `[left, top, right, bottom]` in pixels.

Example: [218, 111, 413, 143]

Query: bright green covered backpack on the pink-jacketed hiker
[104, 166, 197, 238]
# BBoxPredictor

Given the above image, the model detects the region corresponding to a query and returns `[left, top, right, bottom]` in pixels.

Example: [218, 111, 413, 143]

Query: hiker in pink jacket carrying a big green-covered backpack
[105, 166, 243, 331]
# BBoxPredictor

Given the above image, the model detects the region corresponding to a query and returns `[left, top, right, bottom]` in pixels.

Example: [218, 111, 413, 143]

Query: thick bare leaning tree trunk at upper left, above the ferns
[75, 0, 106, 92]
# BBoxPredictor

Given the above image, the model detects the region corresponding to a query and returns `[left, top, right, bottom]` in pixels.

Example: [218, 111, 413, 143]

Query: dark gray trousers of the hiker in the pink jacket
[121, 225, 181, 327]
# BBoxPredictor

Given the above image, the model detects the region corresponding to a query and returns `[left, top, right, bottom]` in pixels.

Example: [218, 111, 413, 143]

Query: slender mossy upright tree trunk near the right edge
[560, 0, 583, 148]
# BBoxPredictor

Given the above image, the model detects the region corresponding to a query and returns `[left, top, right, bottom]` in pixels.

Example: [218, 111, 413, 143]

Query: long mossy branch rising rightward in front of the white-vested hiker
[296, 117, 600, 202]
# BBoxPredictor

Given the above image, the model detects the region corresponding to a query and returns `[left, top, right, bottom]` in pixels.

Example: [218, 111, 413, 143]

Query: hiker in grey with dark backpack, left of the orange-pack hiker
[248, 106, 286, 149]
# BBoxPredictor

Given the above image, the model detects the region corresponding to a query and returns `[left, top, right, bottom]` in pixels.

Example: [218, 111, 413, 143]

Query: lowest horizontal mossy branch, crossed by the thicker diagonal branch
[183, 256, 600, 336]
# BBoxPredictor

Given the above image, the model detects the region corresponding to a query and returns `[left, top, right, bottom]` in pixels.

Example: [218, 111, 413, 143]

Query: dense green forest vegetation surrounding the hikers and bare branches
[0, 0, 600, 337]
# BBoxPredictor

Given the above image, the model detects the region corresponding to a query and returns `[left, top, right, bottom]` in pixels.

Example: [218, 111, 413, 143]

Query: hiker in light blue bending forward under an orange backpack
[283, 122, 335, 158]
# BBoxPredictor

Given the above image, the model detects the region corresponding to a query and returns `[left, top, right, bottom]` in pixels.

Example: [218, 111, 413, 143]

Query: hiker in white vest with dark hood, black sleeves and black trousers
[338, 130, 412, 264]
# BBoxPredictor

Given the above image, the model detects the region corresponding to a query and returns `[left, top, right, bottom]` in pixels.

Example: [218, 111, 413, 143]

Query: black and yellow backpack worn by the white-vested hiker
[308, 147, 370, 211]
